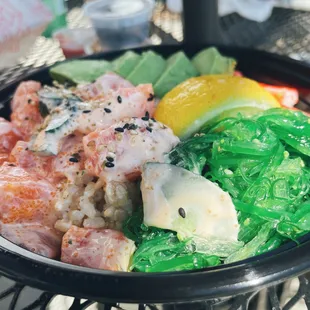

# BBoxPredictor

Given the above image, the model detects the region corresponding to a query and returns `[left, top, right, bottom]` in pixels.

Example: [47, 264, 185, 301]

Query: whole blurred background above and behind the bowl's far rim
[0, 0, 310, 86]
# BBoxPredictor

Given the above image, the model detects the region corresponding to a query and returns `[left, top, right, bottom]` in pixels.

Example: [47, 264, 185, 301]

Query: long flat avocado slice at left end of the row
[49, 60, 112, 84]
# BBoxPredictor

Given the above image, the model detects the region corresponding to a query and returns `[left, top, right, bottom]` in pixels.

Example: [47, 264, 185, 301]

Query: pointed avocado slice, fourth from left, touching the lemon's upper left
[154, 52, 199, 98]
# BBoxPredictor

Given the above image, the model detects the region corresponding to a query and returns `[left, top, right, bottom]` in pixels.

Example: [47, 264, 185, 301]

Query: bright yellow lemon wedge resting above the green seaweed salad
[155, 75, 280, 139]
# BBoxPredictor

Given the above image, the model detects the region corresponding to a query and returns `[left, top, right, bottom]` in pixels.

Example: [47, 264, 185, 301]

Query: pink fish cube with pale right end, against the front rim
[61, 226, 135, 271]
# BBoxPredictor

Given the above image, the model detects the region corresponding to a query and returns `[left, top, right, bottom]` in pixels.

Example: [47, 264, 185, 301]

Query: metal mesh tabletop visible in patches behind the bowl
[0, 2, 310, 88]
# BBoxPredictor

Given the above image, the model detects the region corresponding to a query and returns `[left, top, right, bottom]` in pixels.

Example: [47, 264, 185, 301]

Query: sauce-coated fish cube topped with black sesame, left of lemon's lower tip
[83, 115, 179, 183]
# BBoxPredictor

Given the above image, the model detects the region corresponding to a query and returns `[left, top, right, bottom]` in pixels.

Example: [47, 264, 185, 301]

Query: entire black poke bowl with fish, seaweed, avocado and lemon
[0, 45, 310, 303]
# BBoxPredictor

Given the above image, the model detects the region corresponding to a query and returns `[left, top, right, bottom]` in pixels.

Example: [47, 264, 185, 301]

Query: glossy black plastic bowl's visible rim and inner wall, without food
[0, 45, 310, 303]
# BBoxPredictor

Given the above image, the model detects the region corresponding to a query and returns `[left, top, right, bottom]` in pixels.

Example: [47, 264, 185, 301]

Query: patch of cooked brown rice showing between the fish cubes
[55, 175, 140, 232]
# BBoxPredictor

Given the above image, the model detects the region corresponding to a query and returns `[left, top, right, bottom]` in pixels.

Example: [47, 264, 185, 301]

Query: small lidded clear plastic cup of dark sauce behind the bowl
[84, 0, 154, 49]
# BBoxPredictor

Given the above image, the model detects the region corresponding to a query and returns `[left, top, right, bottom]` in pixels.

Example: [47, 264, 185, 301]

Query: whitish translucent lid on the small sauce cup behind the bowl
[83, 0, 154, 29]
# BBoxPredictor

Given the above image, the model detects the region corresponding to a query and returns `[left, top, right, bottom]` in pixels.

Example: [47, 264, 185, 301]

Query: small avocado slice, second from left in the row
[112, 51, 141, 78]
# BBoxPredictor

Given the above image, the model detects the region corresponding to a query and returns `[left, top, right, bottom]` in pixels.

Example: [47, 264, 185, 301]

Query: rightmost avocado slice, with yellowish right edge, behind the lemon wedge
[192, 47, 237, 75]
